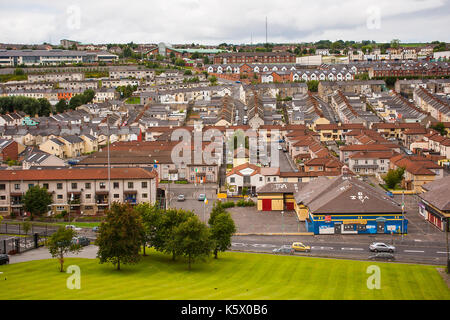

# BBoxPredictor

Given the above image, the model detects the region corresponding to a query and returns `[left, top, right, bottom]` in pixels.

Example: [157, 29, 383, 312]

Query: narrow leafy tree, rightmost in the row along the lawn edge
[209, 212, 236, 259]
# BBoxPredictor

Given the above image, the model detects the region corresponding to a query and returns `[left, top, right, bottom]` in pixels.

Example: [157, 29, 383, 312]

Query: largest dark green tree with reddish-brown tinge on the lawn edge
[96, 202, 144, 270]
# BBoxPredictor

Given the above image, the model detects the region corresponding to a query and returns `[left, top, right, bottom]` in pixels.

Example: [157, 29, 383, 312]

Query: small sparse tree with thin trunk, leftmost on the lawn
[47, 227, 81, 272]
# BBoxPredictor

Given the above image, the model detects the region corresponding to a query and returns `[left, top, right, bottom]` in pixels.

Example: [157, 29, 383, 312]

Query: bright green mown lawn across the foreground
[0, 251, 450, 300]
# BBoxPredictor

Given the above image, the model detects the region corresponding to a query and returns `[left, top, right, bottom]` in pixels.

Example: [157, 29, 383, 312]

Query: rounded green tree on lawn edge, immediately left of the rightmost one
[173, 215, 212, 270]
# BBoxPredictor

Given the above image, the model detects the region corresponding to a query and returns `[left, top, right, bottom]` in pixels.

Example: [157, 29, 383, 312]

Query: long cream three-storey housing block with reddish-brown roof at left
[0, 168, 157, 216]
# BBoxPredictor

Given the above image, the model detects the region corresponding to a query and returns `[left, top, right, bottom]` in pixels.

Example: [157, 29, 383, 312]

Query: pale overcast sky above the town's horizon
[0, 0, 450, 44]
